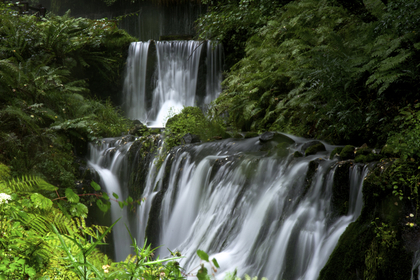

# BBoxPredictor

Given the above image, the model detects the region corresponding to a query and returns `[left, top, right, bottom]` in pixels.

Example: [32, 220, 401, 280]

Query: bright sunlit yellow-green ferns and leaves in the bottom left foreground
[0, 168, 187, 280]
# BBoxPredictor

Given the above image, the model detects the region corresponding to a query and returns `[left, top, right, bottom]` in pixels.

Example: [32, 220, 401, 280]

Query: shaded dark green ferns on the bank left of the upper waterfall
[0, 4, 134, 188]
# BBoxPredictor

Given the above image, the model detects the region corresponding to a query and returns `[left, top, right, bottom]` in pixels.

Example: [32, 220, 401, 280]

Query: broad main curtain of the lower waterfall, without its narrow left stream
[126, 138, 367, 279]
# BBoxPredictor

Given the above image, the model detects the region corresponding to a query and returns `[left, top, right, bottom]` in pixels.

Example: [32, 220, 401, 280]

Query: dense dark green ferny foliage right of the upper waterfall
[199, 0, 420, 149]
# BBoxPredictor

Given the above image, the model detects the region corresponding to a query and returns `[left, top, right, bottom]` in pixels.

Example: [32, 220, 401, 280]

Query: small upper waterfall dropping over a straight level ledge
[123, 41, 223, 127]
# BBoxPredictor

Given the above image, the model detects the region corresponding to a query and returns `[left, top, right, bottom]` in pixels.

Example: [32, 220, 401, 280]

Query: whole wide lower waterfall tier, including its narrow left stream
[90, 133, 367, 280]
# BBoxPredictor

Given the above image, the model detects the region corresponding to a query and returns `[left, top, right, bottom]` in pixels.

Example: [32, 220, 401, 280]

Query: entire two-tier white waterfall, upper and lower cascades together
[90, 41, 367, 280]
